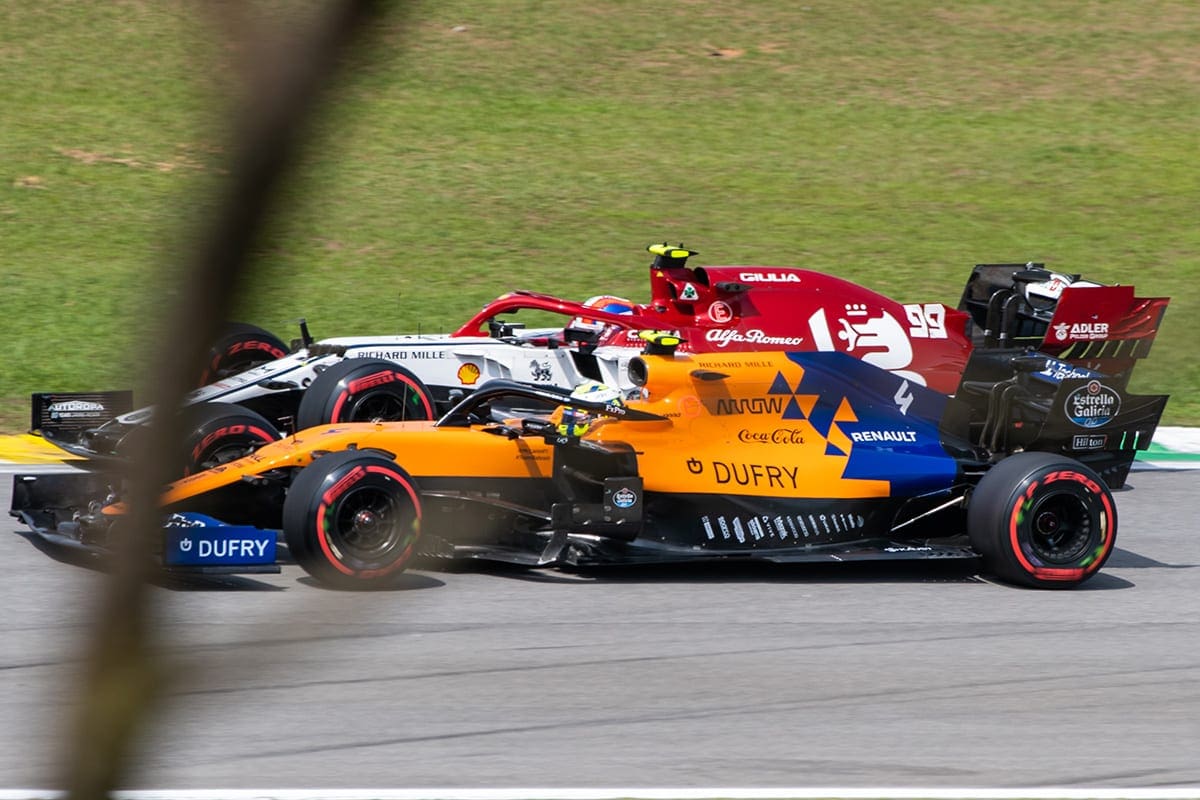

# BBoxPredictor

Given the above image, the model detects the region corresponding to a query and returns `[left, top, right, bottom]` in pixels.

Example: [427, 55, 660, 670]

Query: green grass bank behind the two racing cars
[0, 0, 1200, 432]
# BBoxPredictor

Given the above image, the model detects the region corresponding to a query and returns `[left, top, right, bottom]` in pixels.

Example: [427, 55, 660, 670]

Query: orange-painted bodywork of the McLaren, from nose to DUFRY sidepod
[163, 353, 890, 506]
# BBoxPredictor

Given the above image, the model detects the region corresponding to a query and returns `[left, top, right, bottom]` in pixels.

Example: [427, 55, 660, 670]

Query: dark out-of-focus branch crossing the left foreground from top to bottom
[62, 0, 398, 800]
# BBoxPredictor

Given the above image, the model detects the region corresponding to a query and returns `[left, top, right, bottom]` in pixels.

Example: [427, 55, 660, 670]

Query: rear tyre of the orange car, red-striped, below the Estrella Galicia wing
[967, 452, 1117, 589]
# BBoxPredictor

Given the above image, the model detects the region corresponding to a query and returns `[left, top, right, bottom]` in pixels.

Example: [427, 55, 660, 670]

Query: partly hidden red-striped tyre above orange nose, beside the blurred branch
[180, 403, 281, 475]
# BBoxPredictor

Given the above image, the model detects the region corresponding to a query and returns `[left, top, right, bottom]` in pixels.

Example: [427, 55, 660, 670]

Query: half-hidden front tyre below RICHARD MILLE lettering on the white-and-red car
[296, 359, 433, 431]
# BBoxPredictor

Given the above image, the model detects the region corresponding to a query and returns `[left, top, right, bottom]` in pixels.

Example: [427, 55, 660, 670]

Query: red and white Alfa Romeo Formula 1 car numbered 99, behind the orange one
[32, 245, 1166, 474]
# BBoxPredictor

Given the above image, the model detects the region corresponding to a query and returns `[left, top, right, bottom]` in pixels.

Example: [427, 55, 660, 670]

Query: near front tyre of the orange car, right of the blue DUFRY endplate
[283, 451, 421, 589]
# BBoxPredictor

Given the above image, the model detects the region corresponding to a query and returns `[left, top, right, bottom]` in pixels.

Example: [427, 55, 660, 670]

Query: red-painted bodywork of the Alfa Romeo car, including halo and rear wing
[452, 265, 1168, 395]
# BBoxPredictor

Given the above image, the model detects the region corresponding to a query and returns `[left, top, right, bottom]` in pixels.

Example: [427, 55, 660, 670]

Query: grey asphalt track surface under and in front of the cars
[0, 471, 1200, 789]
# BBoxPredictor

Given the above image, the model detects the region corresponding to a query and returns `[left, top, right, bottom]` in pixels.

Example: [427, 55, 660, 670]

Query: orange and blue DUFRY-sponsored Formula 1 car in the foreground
[13, 326, 1166, 588]
